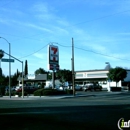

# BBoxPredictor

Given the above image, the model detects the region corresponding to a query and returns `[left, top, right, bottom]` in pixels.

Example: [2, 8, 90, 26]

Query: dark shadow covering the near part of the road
[0, 105, 130, 130]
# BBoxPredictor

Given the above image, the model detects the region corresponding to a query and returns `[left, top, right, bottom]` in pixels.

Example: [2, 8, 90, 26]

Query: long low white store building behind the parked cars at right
[75, 69, 130, 91]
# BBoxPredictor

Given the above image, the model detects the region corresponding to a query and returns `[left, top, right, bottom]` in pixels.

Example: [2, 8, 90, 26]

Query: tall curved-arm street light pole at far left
[0, 37, 11, 98]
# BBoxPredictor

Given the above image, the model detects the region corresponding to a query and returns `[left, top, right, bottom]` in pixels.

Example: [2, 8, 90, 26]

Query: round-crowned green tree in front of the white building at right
[107, 67, 127, 87]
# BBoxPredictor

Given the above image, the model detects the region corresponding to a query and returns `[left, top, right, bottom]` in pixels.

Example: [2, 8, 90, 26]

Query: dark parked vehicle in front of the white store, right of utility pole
[83, 83, 102, 91]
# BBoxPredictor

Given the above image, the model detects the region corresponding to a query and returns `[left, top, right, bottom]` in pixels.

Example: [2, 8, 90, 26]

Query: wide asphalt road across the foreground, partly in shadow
[0, 92, 130, 130]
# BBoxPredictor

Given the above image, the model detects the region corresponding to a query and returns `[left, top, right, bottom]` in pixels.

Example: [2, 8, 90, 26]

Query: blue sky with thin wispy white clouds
[0, 0, 130, 75]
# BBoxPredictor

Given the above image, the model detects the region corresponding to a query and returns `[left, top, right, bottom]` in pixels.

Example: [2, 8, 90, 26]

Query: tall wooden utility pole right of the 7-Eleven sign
[72, 38, 75, 96]
